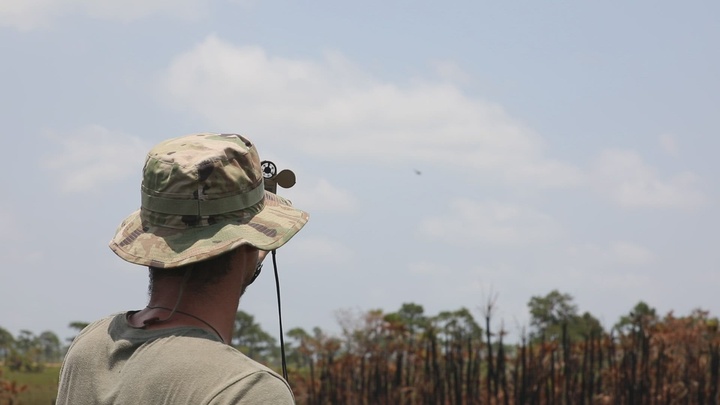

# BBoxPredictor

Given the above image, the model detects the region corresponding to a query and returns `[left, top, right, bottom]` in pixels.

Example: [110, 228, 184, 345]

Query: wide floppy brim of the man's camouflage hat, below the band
[110, 192, 309, 268]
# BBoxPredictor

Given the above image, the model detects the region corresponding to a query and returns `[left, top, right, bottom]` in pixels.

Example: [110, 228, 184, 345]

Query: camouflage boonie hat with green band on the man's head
[110, 133, 308, 268]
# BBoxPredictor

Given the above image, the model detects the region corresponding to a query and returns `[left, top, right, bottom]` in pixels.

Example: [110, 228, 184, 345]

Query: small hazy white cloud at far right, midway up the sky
[592, 150, 707, 208]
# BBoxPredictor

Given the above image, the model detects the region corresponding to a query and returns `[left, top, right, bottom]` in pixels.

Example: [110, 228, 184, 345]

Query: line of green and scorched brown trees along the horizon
[0, 290, 720, 405]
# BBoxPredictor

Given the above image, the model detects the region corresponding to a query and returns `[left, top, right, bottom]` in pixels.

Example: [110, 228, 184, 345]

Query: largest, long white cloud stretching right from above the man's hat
[162, 36, 582, 187]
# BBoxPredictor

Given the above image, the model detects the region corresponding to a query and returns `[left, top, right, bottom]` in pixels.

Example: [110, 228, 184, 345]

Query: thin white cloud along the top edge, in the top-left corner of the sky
[0, 0, 210, 31]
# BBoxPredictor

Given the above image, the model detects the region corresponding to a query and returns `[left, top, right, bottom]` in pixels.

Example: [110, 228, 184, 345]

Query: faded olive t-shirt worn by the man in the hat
[57, 314, 295, 405]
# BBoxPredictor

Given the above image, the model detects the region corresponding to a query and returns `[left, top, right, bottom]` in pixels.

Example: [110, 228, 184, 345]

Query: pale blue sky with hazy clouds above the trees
[0, 0, 720, 338]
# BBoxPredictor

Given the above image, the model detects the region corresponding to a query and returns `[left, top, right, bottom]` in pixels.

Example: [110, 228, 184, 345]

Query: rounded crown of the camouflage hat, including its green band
[141, 133, 264, 228]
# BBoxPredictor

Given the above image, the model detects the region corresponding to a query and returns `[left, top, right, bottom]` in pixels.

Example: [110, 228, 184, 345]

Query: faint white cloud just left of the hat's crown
[43, 126, 149, 192]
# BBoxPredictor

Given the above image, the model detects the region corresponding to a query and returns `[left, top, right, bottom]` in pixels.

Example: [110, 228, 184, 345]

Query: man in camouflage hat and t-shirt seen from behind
[57, 133, 308, 405]
